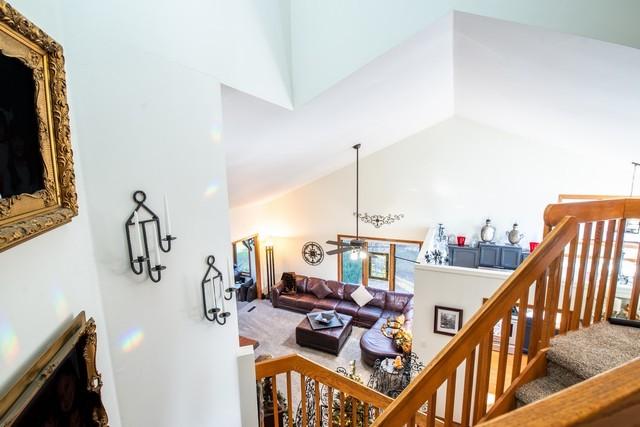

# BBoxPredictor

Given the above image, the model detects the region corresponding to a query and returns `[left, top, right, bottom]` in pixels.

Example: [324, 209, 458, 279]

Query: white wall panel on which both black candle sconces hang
[58, 1, 240, 426]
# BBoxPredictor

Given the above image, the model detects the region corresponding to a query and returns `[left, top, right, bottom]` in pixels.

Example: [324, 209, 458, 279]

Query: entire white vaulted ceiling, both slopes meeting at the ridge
[223, 12, 640, 206]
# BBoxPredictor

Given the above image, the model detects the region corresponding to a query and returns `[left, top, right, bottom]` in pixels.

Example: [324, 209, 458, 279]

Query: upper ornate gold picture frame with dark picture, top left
[0, 0, 78, 251]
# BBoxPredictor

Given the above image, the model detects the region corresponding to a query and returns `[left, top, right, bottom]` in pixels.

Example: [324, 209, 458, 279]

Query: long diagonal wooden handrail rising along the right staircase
[373, 217, 577, 427]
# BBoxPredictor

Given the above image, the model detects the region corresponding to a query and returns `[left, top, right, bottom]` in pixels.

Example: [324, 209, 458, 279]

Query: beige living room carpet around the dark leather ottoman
[238, 300, 373, 383]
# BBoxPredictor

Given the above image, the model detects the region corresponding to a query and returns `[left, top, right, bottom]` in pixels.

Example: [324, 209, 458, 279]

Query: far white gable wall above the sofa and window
[231, 117, 629, 288]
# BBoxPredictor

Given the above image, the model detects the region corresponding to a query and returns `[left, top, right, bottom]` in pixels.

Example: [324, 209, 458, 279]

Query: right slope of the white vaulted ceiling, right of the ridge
[453, 13, 640, 157]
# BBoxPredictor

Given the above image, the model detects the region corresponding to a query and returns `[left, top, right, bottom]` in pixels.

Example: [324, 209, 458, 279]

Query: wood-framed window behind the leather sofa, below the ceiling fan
[338, 235, 422, 293]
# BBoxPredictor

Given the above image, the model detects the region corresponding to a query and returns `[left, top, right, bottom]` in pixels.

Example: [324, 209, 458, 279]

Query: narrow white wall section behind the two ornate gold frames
[0, 0, 120, 427]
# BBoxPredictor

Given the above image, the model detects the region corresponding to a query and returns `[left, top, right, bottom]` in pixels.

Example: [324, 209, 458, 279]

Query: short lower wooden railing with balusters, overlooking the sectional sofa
[256, 354, 392, 427]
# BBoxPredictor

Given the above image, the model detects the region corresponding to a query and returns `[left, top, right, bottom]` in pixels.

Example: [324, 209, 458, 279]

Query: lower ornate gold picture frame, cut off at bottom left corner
[0, 311, 109, 427]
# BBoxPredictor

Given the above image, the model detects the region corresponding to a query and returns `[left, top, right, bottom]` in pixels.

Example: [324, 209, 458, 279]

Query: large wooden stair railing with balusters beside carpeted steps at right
[373, 198, 640, 427]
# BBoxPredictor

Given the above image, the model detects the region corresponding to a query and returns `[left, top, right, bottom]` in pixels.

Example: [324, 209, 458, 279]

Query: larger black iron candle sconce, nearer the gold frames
[124, 190, 176, 283]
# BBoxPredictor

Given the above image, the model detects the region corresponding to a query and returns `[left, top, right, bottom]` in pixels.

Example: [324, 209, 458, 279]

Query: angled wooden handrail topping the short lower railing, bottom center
[256, 354, 393, 408]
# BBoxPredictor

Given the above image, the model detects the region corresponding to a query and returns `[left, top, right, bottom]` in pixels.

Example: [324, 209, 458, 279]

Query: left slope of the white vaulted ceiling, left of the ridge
[222, 16, 453, 206]
